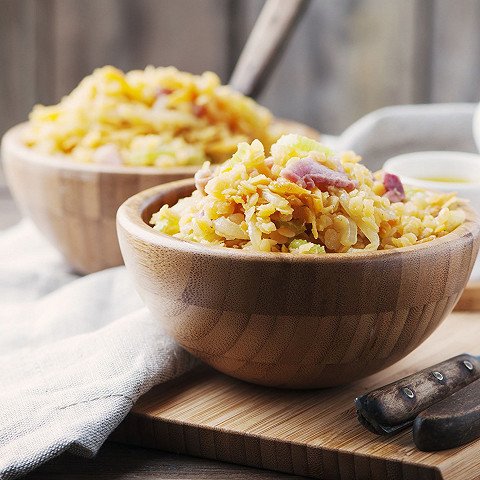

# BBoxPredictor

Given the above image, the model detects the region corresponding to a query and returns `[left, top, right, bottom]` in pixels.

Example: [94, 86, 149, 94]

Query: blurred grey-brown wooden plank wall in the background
[0, 0, 480, 140]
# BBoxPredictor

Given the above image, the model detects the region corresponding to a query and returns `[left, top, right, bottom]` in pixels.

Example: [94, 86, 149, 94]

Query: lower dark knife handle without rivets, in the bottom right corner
[413, 380, 480, 452]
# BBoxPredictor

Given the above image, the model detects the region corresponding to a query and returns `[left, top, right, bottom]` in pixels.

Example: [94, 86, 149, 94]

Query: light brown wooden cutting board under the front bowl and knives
[112, 313, 480, 480]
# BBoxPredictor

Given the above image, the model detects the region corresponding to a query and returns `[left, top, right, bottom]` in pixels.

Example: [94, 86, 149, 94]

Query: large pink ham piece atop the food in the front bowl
[280, 157, 357, 192]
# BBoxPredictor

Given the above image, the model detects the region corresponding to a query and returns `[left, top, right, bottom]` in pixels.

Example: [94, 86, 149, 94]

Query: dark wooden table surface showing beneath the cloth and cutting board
[0, 188, 302, 480]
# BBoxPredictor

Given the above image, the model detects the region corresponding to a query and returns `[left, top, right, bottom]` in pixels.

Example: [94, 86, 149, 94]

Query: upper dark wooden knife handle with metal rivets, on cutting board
[355, 354, 480, 435]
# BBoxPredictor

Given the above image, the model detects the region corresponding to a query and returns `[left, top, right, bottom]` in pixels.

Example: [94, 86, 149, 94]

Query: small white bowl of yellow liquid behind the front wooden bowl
[383, 152, 480, 279]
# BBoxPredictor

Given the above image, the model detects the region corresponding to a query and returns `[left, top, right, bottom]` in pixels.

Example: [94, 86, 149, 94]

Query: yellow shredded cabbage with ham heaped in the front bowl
[151, 134, 465, 254]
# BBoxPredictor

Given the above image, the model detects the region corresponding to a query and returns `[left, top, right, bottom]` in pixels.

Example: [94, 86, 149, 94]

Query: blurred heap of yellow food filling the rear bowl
[24, 66, 276, 167]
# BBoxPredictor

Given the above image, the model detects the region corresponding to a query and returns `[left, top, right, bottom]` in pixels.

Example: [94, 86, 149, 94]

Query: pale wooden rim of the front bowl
[117, 178, 480, 263]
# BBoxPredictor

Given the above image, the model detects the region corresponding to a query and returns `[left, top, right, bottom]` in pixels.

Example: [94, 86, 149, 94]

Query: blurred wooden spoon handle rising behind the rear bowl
[230, 0, 309, 97]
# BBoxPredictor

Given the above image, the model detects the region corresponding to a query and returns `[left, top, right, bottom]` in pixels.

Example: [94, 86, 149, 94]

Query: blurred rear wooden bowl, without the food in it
[1, 120, 319, 273]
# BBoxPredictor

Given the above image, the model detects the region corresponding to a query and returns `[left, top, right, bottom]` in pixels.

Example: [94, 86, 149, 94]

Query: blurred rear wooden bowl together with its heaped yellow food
[1, 67, 319, 273]
